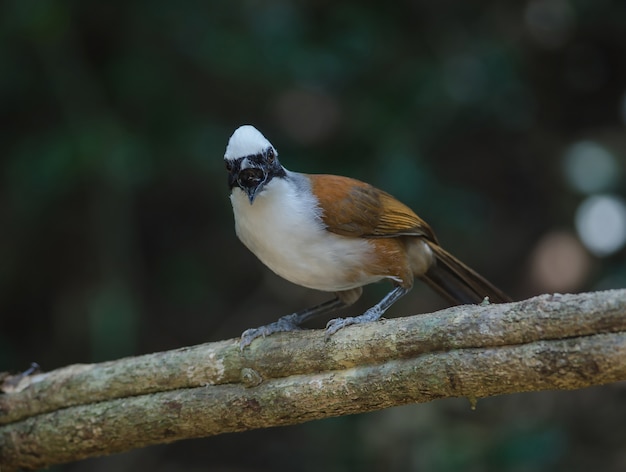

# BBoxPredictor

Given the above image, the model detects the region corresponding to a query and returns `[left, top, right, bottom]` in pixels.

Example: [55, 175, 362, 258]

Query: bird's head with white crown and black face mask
[224, 125, 285, 204]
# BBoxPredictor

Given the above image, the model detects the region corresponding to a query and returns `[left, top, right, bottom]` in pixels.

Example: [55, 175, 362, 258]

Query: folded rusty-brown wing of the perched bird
[309, 175, 437, 242]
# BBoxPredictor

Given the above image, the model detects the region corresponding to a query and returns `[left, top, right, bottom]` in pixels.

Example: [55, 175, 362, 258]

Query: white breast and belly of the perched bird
[231, 172, 383, 292]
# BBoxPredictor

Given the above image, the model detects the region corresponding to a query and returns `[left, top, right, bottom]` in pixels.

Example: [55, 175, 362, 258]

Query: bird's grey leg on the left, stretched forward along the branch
[240, 287, 363, 350]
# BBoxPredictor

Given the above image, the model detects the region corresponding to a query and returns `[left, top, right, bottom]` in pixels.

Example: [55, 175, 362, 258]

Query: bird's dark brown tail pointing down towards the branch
[420, 241, 511, 304]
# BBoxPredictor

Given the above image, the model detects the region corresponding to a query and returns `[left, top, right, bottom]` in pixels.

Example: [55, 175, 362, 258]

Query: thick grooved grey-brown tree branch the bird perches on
[0, 290, 626, 472]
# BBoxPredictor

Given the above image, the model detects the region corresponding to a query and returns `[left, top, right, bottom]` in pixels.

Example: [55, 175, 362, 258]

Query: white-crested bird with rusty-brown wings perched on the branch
[224, 125, 511, 349]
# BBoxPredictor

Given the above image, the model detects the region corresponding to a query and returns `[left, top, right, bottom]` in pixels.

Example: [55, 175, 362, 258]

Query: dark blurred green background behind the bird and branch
[0, 0, 626, 472]
